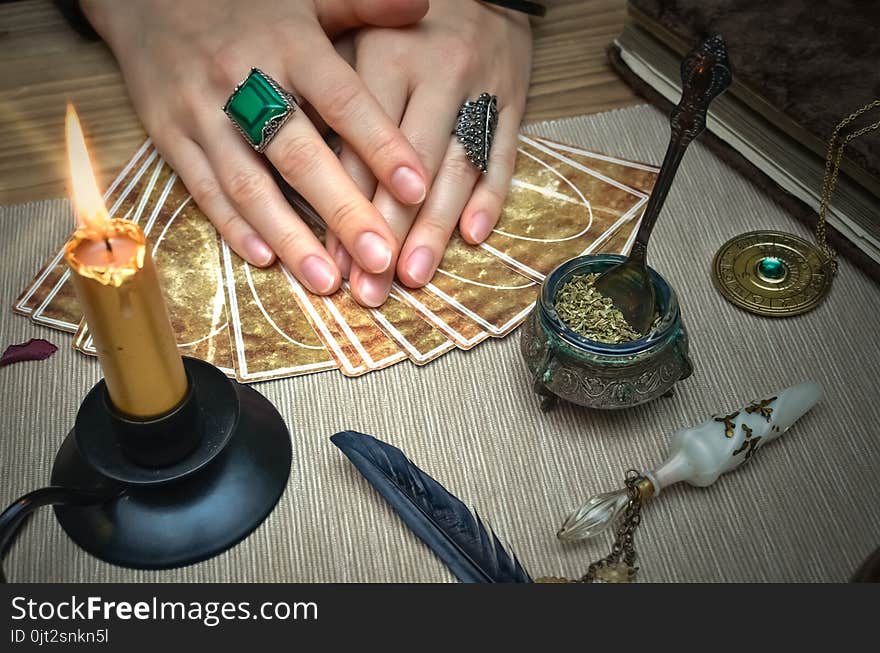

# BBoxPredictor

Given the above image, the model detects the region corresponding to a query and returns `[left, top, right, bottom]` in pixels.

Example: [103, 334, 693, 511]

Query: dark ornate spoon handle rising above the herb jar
[630, 36, 732, 259]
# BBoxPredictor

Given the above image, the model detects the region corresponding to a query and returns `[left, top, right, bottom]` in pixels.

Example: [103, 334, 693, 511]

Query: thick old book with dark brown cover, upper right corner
[609, 0, 880, 279]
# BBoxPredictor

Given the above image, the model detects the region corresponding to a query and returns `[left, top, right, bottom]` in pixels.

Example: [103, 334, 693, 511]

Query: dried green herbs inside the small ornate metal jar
[556, 274, 660, 344]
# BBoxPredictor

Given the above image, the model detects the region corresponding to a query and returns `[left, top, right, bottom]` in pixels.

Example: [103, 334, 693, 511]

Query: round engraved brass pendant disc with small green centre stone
[712, 231, 834, 317]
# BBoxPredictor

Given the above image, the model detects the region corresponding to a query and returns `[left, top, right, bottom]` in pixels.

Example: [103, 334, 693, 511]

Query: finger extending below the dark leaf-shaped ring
[397, 141, 480, 288]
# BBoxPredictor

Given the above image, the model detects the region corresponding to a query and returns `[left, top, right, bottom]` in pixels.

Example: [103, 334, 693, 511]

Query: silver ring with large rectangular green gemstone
[223, 68, 297, 152]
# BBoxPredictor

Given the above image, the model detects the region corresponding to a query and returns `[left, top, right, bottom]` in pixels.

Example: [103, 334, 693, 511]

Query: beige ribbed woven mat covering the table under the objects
[0, 106, 880, 582]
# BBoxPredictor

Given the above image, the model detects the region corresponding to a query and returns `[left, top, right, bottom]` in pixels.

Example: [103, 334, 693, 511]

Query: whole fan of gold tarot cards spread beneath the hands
[13, 136, 657, 383]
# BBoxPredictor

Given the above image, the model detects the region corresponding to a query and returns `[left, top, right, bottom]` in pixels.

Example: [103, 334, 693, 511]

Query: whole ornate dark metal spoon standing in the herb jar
[596, 36, 731, 334]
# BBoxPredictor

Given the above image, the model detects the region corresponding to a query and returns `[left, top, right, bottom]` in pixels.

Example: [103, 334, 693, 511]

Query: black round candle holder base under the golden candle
[52, 358, 292, 569]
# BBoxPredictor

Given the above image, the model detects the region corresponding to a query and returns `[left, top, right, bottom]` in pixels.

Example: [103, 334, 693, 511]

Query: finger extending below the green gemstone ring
[265, 93, 397, 272]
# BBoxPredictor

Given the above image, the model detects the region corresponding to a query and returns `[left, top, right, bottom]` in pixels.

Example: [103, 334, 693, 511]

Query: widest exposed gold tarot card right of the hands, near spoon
[480, 135, 652, 281]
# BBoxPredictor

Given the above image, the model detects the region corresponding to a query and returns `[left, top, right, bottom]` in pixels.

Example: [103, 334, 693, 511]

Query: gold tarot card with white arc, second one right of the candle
[220, 242, 337, 383]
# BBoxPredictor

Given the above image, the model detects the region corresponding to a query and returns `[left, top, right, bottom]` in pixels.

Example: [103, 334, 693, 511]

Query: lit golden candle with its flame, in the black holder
[64, 105, 187, 419]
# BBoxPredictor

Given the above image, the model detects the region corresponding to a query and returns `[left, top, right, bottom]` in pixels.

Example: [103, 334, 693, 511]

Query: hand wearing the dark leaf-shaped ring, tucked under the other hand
[326, 0, 532, 306]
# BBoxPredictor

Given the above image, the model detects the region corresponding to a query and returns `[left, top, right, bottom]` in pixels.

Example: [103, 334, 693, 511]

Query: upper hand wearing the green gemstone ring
[82, 0, 428, 294]
